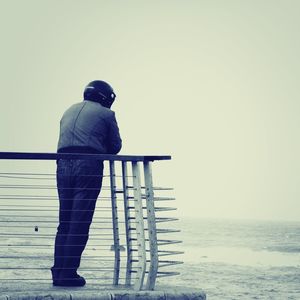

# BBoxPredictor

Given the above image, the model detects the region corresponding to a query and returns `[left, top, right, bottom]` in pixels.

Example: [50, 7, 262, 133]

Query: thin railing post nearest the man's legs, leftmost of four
[109, 160, 120, 285]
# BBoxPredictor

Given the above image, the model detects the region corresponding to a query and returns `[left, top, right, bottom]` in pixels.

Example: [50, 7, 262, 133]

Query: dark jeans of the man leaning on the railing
[52, 159, 103, 274]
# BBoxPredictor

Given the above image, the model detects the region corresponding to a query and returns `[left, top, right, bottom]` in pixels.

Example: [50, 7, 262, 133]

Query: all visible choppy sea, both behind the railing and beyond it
[0, 209, 300, 300]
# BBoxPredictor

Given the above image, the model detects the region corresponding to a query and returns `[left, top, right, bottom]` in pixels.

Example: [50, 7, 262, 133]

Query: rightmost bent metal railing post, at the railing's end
[144, 161, 158, 290]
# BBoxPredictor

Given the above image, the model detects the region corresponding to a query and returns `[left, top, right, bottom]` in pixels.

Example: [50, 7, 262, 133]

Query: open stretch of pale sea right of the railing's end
[159, 218, 300, 299]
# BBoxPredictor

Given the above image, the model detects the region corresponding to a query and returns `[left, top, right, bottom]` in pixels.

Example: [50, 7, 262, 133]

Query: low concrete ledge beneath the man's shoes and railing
[0, 287, 206, 300]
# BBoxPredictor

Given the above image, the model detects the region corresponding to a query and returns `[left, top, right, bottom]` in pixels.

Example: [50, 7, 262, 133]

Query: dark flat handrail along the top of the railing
[0, 152, 171, 162]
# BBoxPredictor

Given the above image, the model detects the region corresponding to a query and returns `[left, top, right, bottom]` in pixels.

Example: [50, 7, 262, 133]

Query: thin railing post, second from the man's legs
[122, 161, 132, 286]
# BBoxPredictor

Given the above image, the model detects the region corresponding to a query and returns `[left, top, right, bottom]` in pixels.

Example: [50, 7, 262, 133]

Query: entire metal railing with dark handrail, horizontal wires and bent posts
[0, 152, 183, 290]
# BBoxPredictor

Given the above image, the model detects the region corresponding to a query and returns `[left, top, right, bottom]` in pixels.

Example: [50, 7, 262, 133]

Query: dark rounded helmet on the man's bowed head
[83, 80, 116, 108]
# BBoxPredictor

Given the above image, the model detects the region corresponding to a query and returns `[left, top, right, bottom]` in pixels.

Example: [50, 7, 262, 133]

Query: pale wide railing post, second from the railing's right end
[132, 162, 146, 290]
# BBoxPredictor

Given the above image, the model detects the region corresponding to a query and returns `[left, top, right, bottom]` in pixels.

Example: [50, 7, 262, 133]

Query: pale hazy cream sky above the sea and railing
[0, 0, 300, 221]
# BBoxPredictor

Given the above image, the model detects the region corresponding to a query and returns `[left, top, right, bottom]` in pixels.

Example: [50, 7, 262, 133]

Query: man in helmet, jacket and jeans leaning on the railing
[51, 80, 122, 286]
